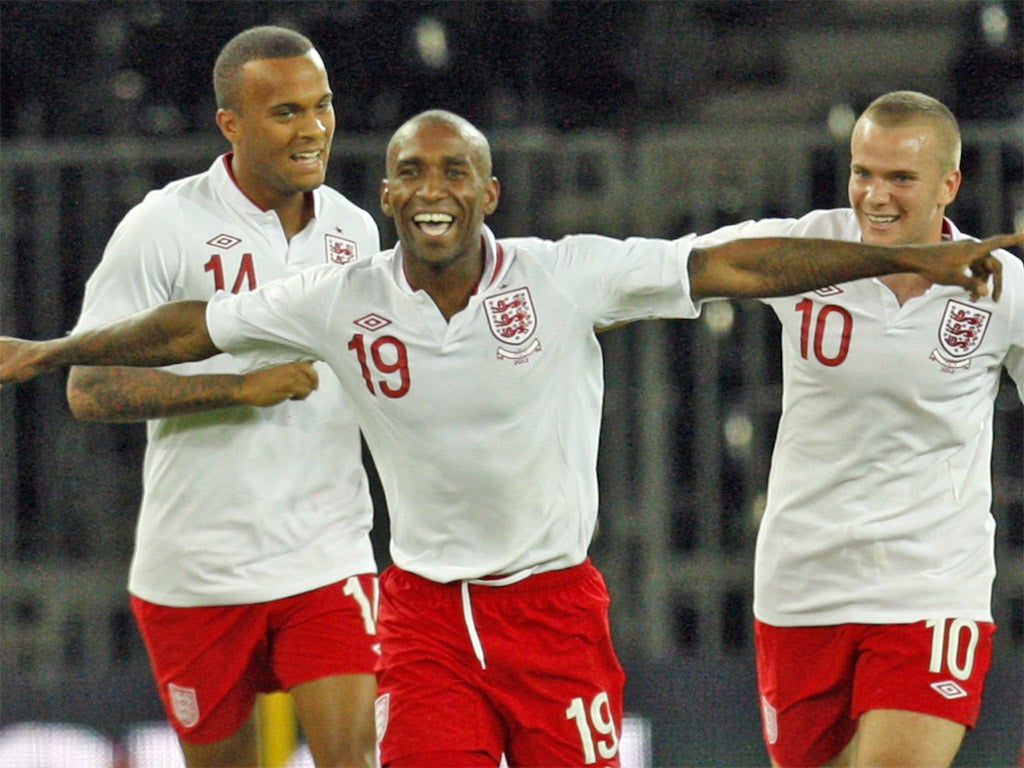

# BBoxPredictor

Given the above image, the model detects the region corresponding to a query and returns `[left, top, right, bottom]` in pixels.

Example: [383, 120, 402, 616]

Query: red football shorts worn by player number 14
[131, 573, 378, 743]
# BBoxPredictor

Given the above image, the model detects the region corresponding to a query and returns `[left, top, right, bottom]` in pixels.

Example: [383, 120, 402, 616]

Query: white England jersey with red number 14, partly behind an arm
[77, 156, 380, 606]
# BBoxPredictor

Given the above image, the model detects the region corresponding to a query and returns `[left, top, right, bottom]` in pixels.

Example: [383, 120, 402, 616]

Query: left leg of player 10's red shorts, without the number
[755, 622, 858, 766]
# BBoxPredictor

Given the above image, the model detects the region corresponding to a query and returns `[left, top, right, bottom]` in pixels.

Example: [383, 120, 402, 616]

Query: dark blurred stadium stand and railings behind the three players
[0, 0, 1024, 768]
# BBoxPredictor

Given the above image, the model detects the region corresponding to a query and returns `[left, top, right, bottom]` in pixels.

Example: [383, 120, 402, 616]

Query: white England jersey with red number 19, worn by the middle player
[207, 231, 699, 583]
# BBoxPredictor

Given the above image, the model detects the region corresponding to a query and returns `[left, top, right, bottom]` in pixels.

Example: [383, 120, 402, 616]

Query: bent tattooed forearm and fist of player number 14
[68, 361, 319, 422]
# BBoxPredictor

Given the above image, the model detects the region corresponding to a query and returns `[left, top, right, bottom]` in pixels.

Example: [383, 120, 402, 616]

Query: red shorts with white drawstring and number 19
[377, 560, 626, 768]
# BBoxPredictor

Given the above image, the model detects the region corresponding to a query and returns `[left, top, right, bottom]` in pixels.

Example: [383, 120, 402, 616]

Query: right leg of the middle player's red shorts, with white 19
[472, 561, 626, 766]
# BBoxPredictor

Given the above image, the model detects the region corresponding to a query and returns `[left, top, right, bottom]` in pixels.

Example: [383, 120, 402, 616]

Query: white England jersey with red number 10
[698, 209, 1024, 627]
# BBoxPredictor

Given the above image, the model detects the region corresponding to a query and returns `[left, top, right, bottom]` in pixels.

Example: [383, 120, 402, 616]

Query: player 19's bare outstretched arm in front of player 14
[0, 301, 211, 384]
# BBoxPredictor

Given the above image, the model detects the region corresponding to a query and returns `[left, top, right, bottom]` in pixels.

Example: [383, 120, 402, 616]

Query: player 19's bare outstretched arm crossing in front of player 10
[689, 232, 1024, 300]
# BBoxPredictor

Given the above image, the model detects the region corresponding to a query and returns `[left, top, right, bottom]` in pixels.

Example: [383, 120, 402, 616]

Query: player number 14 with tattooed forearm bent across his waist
[60, 27, 380, 767]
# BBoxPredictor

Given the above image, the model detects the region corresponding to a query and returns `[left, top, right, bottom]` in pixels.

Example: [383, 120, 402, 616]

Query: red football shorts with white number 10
[755, 618, 995, 766]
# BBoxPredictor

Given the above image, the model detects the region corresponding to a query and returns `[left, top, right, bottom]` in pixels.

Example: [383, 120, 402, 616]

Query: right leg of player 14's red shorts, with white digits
[267, 573, 379, 690]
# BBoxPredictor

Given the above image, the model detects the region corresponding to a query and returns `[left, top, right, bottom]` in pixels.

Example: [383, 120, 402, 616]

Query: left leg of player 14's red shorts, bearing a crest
[131, 596, 267, 744]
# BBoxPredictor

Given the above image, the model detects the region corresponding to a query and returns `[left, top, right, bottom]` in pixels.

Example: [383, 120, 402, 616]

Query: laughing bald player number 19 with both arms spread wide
[0, 111, 1024, 768]
